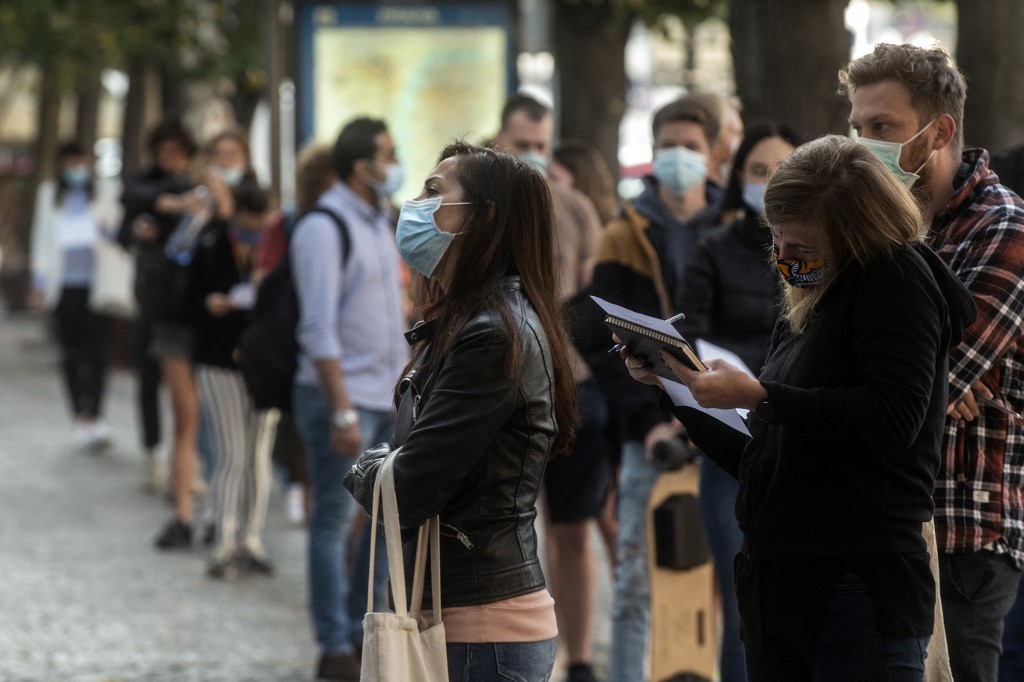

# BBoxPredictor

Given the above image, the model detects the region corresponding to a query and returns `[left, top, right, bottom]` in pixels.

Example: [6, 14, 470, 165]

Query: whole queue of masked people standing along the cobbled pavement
[33, 38, 1024, 682]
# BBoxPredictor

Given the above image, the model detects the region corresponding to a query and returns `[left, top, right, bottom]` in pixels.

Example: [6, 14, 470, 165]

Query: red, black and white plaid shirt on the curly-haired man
[929, 150, 1024, 568]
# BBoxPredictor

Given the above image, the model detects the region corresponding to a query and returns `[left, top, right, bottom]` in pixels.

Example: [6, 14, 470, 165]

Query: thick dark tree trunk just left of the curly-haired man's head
[729, 0, 851, 139]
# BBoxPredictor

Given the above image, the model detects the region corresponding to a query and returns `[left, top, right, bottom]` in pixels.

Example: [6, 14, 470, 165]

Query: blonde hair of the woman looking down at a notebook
[765, 135, 925, 332]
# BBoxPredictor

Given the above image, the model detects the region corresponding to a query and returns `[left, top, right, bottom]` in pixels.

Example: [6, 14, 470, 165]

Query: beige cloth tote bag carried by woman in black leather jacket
[359, 450, 449, 682]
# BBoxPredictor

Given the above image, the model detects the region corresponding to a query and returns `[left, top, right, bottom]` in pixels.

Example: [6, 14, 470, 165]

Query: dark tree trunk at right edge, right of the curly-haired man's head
[956, 0, 1024, 152]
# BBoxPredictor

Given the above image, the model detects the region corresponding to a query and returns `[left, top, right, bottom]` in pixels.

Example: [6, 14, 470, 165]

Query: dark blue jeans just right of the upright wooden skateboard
[700, 458, 746, 682]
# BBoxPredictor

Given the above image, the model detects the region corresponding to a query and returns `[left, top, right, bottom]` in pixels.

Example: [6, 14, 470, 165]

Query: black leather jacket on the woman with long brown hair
[345, 278, 556, 608]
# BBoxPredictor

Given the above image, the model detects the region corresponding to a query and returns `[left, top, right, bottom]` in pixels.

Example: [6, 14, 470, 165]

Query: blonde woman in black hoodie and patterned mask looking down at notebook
[626, 135, 976, 682]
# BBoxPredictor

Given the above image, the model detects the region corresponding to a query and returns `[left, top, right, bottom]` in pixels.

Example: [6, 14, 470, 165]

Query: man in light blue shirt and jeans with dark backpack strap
[289, 118, 409, 680]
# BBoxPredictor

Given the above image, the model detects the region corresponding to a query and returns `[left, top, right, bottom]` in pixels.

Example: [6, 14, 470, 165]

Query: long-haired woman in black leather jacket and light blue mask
[345, 143, 578, 681]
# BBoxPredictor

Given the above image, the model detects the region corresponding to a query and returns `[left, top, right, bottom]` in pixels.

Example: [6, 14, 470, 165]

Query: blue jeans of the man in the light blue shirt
[292, 384, 360, 655]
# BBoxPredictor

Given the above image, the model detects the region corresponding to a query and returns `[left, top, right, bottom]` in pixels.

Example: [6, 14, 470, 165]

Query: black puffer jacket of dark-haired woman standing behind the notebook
[679, 211, 781, 374]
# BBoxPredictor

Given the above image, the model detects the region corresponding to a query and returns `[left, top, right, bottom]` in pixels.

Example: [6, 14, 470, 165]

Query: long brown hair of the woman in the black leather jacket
[401, 141, 580, 454]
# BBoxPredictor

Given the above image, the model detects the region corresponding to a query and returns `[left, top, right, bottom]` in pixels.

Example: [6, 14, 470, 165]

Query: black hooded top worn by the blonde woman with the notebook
[674, 242, 975, 645]
